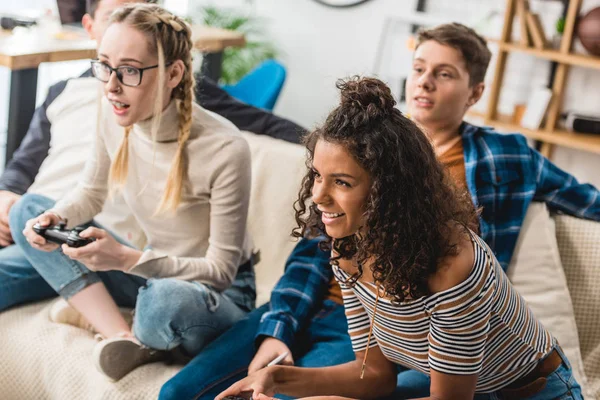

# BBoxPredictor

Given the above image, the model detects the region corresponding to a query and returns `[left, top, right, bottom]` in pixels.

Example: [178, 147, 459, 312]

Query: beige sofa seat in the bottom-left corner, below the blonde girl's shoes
[0, 301, 179, 400]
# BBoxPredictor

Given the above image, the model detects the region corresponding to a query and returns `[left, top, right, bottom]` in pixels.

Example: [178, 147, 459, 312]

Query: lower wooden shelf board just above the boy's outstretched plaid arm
[485, 120, 600, 154]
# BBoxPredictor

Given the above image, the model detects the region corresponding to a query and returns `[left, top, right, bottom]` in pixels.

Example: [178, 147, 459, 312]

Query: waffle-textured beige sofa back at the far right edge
[554, 215, 600, 399]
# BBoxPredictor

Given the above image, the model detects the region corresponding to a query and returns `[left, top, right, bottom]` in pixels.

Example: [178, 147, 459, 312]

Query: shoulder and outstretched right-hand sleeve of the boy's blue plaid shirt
[461, 123, 600, 270]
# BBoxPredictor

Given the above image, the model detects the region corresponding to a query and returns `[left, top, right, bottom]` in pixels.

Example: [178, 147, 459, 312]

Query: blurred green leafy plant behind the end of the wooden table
[190, 5, 279, 85]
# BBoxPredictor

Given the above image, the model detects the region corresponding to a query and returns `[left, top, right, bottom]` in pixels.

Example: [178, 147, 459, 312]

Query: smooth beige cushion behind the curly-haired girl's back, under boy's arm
[507, 202, 587, 396]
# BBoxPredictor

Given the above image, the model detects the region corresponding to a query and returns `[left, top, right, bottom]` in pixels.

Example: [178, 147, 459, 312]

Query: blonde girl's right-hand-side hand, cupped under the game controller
[62, 227, 142, 272]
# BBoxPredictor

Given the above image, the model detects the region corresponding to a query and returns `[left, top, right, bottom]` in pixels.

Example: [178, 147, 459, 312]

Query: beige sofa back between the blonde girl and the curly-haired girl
[243, 132, 306, 306]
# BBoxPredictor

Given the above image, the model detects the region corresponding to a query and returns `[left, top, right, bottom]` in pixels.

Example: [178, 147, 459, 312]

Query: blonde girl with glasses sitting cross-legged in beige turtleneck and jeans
[11, 4, 255, 380]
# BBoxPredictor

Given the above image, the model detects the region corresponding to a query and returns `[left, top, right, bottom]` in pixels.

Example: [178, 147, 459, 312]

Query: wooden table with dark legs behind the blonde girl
[0, 26, 246, 163]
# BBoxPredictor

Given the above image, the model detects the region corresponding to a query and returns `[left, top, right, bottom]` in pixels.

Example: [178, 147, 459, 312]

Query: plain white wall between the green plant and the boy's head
[195, 0, 416, 127]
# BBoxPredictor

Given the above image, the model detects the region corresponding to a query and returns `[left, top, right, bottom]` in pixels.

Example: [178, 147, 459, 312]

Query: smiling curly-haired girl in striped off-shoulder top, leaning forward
[219, 77, 581, 400]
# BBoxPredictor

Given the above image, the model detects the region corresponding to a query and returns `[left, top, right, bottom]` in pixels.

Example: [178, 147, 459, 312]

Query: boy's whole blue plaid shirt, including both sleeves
[257, 123, 600, 347]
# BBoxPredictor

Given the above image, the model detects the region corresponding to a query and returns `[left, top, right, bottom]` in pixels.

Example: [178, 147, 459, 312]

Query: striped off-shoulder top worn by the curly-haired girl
[333, 234, 553, 393]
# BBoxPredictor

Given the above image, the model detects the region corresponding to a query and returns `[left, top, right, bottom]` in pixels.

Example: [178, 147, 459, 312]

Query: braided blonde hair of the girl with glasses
[110, 3, 195, 213]
